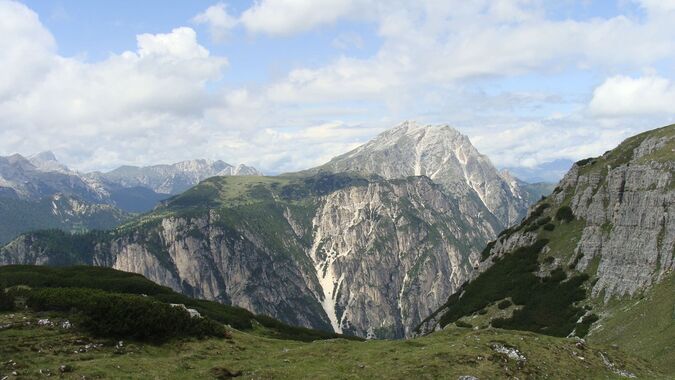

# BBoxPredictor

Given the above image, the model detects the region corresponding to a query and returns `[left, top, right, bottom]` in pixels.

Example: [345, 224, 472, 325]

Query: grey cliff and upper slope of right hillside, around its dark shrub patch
[418, 125, 675, 333]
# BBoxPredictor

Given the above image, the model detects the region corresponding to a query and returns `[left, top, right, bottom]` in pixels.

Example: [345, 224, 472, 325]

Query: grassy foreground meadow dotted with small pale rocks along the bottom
[0, 313, 665, 379]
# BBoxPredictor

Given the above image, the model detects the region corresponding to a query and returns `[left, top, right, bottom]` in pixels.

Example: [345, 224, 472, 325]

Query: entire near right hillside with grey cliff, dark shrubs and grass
[418, 125, 675, 372]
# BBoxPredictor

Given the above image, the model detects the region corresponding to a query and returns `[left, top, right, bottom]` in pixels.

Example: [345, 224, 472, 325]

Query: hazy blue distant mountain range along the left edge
[0, 152, 260, 243]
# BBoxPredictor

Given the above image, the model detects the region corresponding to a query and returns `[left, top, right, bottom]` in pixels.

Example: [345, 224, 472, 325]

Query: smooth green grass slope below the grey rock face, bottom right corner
[588, 273, 675, 375]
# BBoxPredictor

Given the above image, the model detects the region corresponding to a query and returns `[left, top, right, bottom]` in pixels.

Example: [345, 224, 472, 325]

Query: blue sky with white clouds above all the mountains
[0, 0, 675, 180]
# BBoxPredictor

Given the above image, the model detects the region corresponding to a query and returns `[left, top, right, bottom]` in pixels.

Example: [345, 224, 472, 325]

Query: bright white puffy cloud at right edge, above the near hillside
[589, 75, 675, 117]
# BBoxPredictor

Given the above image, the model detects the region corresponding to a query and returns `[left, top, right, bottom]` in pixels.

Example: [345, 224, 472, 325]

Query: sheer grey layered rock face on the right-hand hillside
[555, 131, 675, 300]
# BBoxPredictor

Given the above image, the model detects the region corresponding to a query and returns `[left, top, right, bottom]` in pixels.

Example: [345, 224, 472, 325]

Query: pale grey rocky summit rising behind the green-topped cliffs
[309, 121, 532, 229]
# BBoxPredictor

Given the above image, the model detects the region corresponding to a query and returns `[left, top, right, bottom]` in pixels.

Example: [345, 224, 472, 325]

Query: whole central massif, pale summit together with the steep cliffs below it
[0, 122, 556, 338]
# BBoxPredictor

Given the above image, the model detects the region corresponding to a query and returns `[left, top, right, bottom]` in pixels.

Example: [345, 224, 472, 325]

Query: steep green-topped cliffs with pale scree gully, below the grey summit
[0, 175, 496, 338]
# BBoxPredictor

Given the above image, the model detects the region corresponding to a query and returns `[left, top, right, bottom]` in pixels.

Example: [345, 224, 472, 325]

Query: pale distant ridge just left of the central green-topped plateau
[91, 159, 262, 195]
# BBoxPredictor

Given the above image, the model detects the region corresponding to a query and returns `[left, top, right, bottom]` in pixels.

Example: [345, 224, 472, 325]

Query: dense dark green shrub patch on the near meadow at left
[28, 288, 227, 342]
